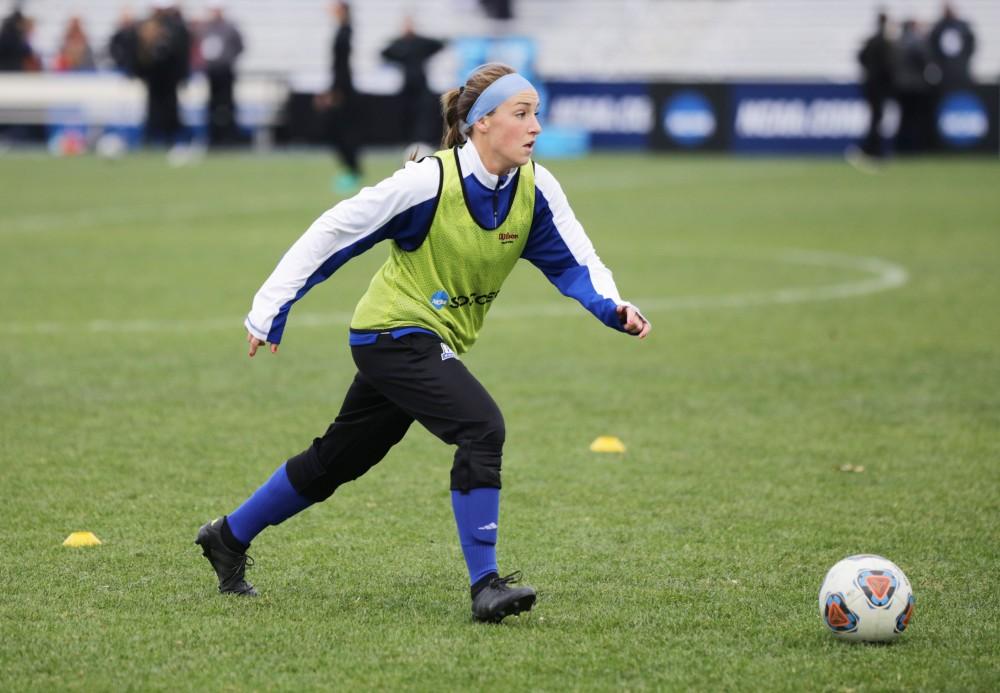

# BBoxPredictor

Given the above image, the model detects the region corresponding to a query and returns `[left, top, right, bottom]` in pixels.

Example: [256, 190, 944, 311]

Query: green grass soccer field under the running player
[0, 154, 1000, 691]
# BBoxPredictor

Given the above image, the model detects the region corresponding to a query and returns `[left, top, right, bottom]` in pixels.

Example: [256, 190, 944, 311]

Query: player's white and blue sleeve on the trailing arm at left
[244, 157, 440, 344]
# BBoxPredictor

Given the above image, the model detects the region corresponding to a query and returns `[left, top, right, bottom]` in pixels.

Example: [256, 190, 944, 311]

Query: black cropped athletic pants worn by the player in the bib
[286, 333, 504, 502]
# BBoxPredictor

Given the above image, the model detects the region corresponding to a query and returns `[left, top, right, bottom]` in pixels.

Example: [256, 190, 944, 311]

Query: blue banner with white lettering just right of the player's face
[542, 82, 655, 149]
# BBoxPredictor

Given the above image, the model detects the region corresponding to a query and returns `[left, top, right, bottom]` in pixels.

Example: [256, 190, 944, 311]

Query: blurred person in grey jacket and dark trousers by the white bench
[198, 2, 243, 147]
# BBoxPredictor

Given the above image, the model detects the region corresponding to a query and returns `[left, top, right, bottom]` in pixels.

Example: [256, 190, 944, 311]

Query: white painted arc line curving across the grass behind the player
[7, 250, 910, 334]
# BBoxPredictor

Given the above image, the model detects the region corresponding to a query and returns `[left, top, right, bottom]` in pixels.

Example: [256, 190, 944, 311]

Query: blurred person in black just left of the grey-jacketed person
[131, 0, 191, 145]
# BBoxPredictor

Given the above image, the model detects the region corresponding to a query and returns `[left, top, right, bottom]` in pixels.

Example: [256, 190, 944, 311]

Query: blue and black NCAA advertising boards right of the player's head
[545, 82, 1000, 154]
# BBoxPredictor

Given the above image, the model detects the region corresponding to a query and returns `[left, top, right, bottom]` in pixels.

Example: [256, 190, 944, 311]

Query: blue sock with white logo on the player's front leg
[451, 488, 500, 585]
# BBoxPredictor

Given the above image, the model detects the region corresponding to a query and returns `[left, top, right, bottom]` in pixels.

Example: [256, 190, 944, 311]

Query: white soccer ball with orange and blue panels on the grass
[819, 554, 914, 642]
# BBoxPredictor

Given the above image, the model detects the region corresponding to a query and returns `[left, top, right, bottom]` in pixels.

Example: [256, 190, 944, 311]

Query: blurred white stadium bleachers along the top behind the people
[21, 0, 1000, 92]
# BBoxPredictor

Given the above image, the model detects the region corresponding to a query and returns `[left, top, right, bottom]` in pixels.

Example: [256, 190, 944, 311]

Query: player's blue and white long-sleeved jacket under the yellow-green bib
[244, 142, 644, 344]
